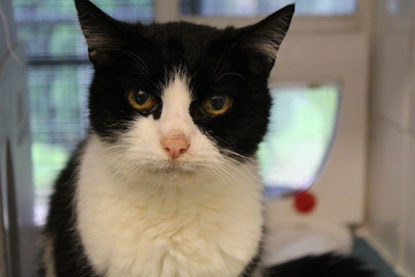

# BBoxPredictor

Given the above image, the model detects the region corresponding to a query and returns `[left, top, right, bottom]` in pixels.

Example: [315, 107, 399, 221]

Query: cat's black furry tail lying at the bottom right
[265, 253, 376, 277]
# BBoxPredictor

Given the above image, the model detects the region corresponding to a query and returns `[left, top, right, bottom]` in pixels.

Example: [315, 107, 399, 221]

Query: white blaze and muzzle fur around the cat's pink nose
[103, 73, 223, 174]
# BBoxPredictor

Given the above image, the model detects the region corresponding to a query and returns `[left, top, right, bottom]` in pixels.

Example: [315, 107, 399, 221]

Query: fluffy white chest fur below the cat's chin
[76, 136, 263, 277]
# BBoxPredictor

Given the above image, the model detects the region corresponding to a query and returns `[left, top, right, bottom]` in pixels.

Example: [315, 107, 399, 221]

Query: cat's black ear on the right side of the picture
[237, 4, 295, 73]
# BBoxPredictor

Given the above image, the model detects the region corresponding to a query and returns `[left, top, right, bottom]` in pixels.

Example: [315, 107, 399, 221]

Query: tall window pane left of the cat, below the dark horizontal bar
[28, 64, 91, 224]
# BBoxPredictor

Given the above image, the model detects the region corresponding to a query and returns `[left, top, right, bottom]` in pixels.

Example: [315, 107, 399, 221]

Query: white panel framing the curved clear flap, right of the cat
[268, 33, 368, 225]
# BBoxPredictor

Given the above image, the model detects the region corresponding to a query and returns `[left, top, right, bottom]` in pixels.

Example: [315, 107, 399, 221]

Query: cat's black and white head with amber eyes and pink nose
[75, 0, 294, 176]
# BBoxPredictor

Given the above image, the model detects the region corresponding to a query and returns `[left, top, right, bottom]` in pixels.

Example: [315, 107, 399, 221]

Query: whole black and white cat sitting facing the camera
[41, 0, 376, 277]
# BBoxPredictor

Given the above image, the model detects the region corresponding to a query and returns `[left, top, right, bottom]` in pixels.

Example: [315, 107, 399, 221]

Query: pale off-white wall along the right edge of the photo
[367, 0, 415, 276]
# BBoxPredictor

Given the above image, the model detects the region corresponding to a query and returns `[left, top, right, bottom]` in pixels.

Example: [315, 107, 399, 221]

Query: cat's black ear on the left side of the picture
[75, 0, 122, 65]
